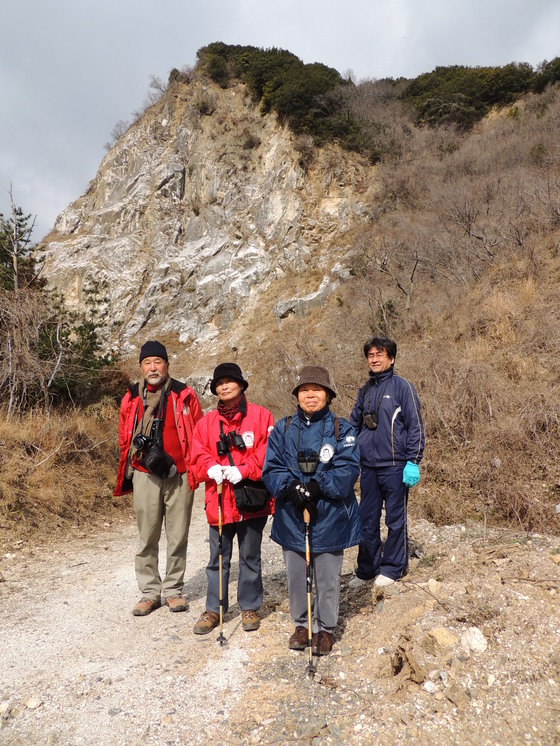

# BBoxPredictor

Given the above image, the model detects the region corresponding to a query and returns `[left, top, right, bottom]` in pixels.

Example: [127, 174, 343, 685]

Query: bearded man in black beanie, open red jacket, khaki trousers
[114, 341, 202, 616]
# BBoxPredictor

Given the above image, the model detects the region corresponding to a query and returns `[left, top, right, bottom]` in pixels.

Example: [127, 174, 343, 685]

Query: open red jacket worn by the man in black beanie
[113, 378, 202, 496]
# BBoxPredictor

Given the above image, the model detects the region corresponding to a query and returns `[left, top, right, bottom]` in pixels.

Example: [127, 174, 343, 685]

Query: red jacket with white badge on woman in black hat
[191, 402, 274, 526]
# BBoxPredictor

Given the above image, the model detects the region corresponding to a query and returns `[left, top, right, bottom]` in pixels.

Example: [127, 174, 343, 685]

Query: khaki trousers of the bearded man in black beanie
[132, 471, 194, 599]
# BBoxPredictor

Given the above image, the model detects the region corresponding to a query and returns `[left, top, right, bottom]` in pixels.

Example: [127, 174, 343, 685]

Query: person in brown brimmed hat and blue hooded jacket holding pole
[262, 365, 361, 655]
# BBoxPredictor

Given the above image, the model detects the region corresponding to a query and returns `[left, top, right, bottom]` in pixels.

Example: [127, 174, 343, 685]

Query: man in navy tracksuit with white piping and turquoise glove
[348, 337, 424, 588]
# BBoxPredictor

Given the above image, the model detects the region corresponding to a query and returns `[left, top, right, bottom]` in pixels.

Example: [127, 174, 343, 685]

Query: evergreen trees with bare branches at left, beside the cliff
[0, 191, 123, 417]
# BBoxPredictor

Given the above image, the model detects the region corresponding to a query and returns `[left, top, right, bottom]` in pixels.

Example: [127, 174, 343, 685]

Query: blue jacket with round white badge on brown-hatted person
[262, 406, 361, 554]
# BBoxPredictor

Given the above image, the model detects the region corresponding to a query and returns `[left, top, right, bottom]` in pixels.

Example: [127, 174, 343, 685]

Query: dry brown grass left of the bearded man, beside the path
[0, 401, 130, 540]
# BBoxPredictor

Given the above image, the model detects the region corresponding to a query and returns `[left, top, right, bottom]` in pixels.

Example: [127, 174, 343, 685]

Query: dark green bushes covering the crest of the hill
[197, 42, 560, 155]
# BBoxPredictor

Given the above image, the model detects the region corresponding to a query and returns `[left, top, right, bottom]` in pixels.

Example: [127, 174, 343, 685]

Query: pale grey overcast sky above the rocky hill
[0, 0, 560, 242]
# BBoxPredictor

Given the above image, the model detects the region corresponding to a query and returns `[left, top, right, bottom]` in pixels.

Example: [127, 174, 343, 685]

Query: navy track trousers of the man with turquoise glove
[356, 465, 408, 580]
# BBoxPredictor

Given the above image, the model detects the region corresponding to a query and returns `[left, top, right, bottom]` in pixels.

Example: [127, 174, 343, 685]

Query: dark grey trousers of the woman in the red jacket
[206, 516, 267, 614]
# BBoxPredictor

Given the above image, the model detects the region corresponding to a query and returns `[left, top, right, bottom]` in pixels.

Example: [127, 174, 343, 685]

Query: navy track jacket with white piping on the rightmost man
[350, 368, 425, 467]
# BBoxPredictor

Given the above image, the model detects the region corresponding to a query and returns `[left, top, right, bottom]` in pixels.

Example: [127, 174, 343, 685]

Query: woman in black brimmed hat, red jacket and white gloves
[191, 363, 274, 635]
